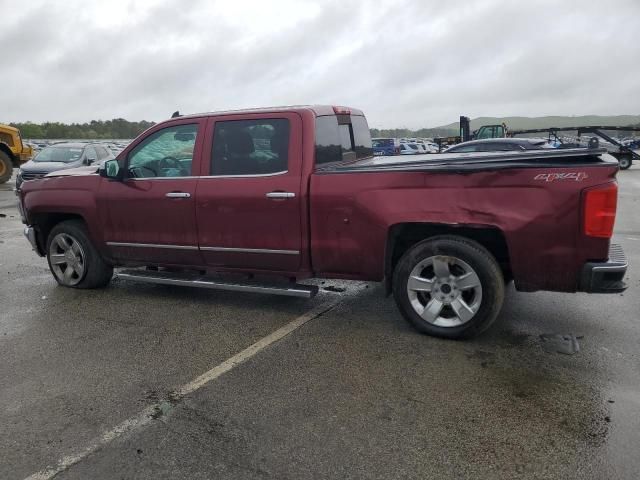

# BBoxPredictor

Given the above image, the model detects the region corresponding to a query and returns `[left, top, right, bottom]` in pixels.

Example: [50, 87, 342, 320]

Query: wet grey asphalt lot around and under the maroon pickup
[0, 165, 640, 479]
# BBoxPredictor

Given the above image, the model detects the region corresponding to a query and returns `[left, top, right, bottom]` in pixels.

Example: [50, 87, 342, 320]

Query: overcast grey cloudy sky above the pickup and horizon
[0, 0, 640, 128]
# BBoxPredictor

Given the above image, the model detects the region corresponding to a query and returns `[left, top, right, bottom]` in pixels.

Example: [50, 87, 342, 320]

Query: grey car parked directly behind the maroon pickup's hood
[16, 143, 115, 189]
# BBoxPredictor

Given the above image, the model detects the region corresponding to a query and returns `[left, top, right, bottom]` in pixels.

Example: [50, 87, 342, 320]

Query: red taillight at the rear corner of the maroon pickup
[583, 182, 618, 238]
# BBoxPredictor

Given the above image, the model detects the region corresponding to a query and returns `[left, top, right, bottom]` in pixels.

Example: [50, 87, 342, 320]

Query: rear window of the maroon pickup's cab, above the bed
[316, 115, 373, 165]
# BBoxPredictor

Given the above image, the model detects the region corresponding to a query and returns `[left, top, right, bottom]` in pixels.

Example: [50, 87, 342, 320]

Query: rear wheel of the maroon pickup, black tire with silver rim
[393, 236, 505, 339]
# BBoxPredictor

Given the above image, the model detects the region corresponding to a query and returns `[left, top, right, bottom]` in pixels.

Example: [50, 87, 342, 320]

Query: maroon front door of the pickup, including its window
[101, 119, 206, 265]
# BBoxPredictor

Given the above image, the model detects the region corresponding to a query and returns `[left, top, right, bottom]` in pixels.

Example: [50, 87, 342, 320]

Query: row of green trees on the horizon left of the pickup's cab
[10, 118, 154, 139]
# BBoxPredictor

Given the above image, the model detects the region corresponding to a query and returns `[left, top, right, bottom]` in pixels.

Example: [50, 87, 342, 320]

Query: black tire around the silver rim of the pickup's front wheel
[46, 220, 113, 289]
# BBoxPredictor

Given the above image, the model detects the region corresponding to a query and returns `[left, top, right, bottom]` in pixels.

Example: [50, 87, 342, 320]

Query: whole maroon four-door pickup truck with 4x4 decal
[19, 106, 627, 338]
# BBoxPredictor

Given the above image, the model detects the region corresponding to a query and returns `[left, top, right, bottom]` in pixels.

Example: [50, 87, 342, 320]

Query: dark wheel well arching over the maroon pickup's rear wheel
[385, 223, 513, 294]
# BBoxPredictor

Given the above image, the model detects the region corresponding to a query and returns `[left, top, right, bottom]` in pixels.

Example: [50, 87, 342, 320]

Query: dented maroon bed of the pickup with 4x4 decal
[311, 148, 618, 292]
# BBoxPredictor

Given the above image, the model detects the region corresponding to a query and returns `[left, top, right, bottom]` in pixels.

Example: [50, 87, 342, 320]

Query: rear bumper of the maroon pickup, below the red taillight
[579, 244, 628, 293]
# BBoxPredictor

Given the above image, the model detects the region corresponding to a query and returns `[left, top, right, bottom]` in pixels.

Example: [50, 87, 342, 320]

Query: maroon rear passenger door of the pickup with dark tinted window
[196, 113, 302, 272]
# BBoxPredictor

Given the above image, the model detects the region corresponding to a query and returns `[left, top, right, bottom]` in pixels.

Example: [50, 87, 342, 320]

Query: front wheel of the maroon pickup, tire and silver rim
[47, 220, 113, 288]
